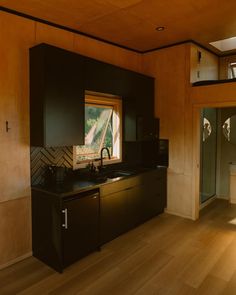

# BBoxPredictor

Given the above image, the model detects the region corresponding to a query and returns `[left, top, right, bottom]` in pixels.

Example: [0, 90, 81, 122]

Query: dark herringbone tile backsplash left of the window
[30, 146, 73, 185]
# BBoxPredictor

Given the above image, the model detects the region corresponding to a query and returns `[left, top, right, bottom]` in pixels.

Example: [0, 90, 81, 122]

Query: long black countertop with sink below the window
[31, 166, 166, 198]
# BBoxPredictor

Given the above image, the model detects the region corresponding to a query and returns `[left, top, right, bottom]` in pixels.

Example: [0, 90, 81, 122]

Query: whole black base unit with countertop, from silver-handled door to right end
[32, 167, 167, 272]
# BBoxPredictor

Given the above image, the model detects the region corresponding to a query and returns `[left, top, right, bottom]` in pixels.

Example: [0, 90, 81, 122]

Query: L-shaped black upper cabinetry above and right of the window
[86, 58, 155, 141]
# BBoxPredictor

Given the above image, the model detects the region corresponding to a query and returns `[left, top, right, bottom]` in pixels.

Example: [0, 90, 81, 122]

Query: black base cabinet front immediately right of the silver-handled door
[100, 190, 128, 244]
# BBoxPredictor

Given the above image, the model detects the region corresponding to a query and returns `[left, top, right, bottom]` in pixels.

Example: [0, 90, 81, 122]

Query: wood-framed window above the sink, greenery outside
[74, 93, 122, 168]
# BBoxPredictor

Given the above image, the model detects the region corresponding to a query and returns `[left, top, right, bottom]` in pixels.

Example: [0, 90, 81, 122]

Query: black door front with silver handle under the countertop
[62, 193, 99, 267]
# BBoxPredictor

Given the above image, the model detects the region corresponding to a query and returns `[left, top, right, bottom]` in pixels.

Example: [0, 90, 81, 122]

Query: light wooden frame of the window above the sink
[73, 91, 122, 169]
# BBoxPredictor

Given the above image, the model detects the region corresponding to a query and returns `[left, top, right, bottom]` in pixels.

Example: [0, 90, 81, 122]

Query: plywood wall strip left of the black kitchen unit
[0, 13, 35, 267]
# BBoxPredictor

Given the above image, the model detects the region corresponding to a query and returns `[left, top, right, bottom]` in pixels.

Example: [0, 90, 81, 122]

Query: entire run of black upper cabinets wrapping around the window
[30, 44, 154, 147]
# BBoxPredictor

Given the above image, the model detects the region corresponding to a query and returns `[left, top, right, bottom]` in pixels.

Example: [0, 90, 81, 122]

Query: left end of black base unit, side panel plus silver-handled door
[32, 189, 100, 272]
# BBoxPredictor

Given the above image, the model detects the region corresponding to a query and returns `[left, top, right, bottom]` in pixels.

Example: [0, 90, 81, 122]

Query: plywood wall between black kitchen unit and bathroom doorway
[143, 44, 195, 218]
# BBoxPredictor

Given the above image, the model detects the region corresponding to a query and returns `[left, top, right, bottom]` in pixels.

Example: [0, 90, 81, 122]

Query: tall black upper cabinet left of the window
[30, 44, 85, 147]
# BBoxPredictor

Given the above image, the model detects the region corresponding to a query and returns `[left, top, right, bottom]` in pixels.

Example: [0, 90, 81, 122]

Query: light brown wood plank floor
[0, 200, 236, 295]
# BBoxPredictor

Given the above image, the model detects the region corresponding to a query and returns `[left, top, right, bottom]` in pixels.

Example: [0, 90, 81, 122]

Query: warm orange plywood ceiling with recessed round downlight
[0, 0, 236, 54]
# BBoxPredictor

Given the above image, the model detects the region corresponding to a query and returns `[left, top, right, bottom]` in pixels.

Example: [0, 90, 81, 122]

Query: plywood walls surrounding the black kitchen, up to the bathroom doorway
[0, 8, 221, 268]
